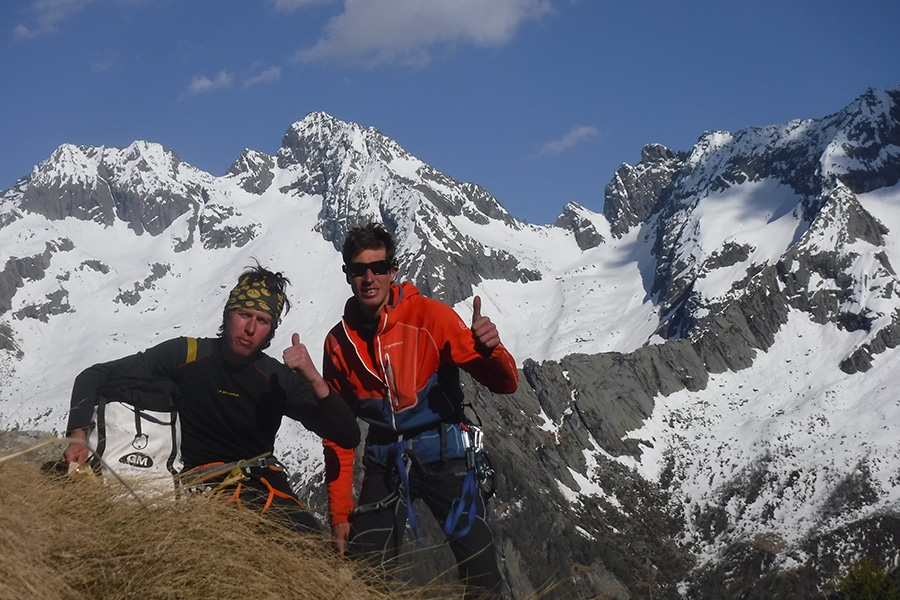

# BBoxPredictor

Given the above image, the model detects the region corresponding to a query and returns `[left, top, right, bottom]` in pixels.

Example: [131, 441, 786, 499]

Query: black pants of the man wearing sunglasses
[349, 459, 502, 598]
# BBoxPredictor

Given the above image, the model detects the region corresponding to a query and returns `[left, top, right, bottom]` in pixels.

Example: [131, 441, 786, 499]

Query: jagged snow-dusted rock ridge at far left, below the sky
[0, 142, 266, 252]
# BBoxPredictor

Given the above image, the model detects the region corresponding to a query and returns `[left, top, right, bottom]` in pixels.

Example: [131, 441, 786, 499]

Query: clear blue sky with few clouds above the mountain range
[0, 0, 900, 223]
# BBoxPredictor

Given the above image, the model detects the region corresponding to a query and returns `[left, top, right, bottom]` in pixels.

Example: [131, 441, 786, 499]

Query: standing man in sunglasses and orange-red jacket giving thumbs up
[322, 224, 518, 598]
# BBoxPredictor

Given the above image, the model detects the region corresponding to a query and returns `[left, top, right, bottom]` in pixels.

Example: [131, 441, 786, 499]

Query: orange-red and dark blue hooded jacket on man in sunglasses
[322, 283, 518, 524]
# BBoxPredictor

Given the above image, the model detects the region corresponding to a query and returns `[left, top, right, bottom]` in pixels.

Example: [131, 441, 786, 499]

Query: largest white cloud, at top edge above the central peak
[296, 0, 552, 65]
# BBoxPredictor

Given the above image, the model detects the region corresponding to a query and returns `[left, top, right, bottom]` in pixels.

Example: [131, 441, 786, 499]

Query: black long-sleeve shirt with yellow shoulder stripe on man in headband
[67, 337, 360, 468]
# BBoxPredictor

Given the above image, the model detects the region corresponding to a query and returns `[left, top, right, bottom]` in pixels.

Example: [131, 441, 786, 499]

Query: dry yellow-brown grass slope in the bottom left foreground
[0, 436, 459, 600]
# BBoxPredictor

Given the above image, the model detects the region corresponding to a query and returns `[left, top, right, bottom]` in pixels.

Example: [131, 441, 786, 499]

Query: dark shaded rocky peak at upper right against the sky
[652, 90, 900, 322]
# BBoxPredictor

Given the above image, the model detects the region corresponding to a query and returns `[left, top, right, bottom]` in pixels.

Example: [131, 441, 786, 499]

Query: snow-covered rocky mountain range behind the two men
[0, 87, 900, 598]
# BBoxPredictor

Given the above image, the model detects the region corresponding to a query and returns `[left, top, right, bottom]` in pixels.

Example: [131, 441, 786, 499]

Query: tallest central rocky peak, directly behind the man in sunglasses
[277, 113, 541, 304]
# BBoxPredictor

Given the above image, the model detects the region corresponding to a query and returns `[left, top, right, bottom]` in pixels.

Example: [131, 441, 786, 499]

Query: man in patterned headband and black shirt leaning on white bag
[63, 264, 360, 530]
